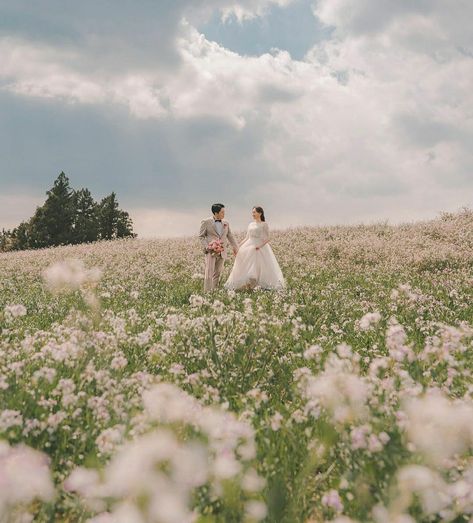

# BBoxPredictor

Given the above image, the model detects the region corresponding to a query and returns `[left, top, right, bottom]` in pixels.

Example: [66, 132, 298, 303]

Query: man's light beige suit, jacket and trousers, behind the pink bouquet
[199, 218, 238, 291]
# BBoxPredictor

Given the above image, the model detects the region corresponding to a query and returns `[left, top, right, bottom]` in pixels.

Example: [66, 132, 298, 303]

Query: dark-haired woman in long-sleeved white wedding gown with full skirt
[225, 207, 286, 290]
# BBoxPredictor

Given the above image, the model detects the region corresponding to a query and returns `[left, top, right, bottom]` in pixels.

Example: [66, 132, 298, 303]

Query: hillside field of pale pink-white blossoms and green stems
[0, 209, 473, 523]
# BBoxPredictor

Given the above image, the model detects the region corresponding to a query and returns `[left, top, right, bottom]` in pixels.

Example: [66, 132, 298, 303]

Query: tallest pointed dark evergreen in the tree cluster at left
[32, 171, 74, 247]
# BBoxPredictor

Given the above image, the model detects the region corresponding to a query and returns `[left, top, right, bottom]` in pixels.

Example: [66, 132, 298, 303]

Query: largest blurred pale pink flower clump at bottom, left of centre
[64, 383, 266, 523]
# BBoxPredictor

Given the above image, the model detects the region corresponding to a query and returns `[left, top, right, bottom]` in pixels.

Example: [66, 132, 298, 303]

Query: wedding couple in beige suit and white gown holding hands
[199, 203, 285, 292]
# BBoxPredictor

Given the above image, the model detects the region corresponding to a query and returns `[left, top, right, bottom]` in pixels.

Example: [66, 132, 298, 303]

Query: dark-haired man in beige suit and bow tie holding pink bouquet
[199, 203, 238, 292]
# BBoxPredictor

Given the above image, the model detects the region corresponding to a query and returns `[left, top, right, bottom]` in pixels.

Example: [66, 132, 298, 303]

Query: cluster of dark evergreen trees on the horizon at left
[0, 172, 136, 251]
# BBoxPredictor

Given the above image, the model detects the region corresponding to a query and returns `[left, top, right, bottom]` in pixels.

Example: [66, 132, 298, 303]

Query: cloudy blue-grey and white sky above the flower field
[0, 0, 473, 236]
